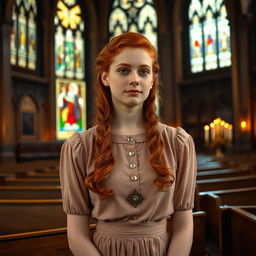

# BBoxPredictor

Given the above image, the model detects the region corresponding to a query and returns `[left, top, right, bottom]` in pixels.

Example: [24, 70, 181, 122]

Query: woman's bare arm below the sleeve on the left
[67, 214, 100, 256]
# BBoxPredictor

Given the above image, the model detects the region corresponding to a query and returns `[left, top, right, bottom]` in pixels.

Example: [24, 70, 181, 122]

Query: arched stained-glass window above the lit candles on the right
[188, 0, 231, 73]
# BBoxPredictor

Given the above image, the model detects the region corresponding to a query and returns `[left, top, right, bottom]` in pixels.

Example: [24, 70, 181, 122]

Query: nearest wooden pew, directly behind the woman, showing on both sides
[0, 212, 205, 256]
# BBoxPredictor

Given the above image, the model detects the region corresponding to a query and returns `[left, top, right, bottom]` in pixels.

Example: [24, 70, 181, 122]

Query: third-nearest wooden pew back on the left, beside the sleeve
[0, 186, 61, 199]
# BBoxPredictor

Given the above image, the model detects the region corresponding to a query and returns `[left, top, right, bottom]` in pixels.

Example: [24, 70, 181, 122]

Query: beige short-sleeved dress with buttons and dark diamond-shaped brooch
[60, 123, 196, 256]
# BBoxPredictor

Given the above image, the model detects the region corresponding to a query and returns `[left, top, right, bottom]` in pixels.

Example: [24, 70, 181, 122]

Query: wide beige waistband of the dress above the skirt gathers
[96, 219, 167, 237]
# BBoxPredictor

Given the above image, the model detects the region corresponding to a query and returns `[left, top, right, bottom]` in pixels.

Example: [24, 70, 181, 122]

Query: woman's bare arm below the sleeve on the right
[167, 210, 193, 256]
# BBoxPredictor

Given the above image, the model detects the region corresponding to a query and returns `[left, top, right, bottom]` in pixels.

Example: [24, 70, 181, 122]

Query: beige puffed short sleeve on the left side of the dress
[60, 133, 91, 215]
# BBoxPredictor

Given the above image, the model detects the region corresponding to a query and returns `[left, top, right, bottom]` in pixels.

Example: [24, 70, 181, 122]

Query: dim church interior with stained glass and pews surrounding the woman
[0, 0, 256, 256]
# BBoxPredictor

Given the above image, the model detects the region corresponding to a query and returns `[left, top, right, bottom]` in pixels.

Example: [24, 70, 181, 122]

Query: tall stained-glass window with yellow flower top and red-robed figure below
[55, 0, 86, 139]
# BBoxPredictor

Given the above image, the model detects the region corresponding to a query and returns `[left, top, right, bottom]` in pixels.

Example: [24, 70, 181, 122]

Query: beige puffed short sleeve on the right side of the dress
[174, 127, 197, 211]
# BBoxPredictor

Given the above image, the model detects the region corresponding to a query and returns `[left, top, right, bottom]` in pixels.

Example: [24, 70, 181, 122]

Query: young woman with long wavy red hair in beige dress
[60, 32, 196, 256]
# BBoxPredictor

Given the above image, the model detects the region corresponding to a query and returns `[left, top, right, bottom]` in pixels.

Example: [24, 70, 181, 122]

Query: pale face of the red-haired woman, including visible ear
[102, 47, 153, 109]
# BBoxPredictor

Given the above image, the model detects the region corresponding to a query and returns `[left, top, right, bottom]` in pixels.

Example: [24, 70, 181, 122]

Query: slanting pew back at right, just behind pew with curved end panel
[196, 175, 256, 192]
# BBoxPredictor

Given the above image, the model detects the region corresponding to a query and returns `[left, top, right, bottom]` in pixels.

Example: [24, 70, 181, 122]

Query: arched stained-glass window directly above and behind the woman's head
[109, 0, 157, 48]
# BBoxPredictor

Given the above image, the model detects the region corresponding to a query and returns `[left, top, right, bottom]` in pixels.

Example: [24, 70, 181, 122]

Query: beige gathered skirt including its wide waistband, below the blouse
[93, 219, 169, 256]
